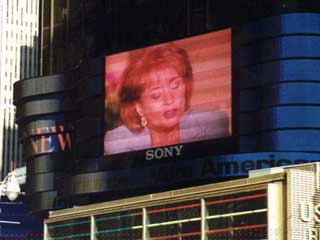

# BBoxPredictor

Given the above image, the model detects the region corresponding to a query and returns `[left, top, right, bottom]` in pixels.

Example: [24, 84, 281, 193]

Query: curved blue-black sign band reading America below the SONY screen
[72, 152, 320, 194]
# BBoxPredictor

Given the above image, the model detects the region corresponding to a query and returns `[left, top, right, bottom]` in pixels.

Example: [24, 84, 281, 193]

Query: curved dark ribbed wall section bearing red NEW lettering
[14, 72, 77, 211]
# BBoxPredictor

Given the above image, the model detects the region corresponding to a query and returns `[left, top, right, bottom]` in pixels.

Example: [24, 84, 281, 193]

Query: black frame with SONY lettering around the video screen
[100, 27, 240, 171]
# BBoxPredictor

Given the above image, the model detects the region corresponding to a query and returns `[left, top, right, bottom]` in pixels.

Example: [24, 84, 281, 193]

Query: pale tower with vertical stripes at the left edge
[0, 0, 39, 179]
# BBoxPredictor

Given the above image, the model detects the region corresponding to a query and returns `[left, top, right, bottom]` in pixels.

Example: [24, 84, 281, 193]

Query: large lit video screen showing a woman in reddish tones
[104, 29, 232, 160]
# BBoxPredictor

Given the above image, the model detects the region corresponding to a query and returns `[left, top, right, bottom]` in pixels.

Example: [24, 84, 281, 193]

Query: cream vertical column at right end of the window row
[268, 182, 285, 240]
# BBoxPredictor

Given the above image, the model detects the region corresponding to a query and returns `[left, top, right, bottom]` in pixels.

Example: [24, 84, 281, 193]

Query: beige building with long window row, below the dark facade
[44, 163, 320, 240]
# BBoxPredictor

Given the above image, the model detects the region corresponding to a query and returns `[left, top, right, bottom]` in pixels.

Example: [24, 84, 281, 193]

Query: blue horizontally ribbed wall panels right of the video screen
[239, 13, 320, 152]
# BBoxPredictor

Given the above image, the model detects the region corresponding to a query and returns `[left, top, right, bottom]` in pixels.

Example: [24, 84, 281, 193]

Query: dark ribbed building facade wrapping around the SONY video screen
[15, 0, 320, 216]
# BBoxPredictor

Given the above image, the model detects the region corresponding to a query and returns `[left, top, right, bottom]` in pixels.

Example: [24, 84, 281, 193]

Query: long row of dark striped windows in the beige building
[47, 189, 268, 240]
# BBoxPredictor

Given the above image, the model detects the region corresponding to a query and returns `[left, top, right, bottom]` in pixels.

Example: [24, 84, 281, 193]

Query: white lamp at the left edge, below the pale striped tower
[0, 171, 21, 201]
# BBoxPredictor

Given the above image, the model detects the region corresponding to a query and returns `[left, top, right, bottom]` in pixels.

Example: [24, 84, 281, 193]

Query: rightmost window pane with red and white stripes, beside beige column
[206, 190, 267, 240]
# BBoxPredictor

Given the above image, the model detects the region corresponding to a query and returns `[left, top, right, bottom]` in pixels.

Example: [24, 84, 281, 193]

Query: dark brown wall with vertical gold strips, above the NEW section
[40, 0, 104, 75]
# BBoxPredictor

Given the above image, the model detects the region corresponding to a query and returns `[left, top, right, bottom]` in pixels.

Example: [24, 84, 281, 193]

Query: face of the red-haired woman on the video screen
[136, 67, 186, 131]
